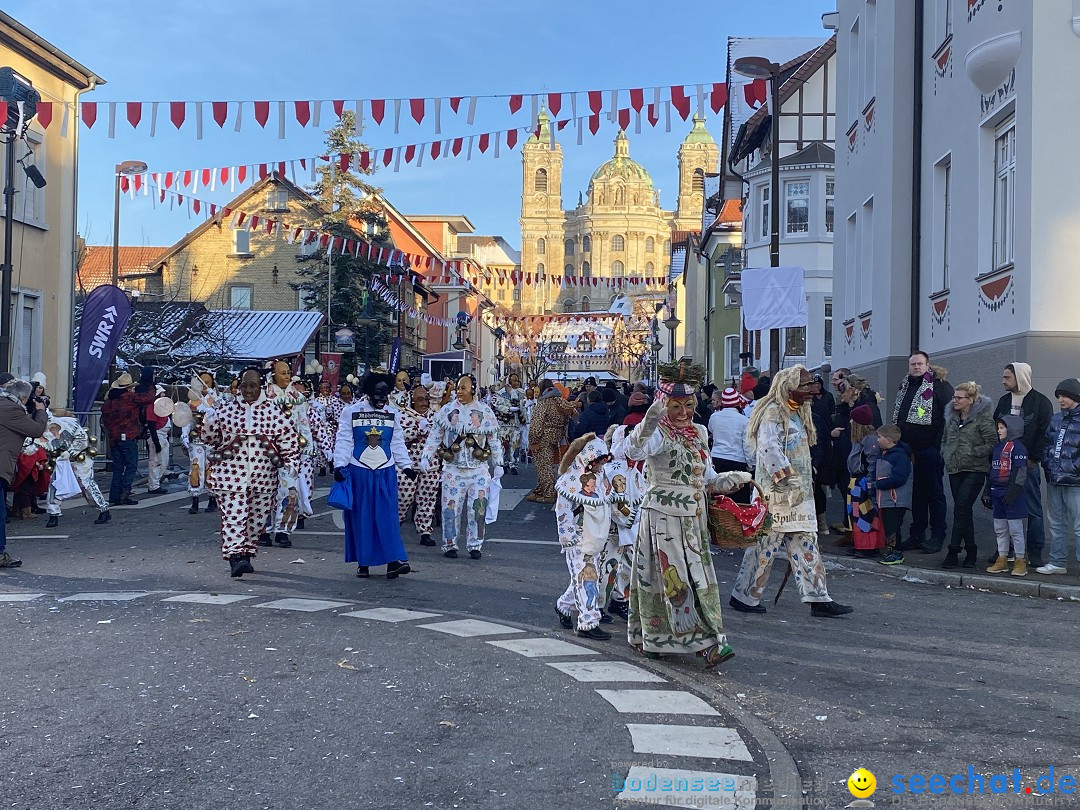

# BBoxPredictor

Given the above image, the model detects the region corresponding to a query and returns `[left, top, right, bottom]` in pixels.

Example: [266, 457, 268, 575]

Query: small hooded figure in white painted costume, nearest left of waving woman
[555, 433, 611, 640]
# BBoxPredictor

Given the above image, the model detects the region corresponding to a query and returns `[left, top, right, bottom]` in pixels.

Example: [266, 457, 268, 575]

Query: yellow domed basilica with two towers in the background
[513, 111, 719, 315]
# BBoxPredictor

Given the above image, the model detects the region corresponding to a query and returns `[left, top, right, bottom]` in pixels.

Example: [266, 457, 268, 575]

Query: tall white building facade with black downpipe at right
[833, 0, 1080, 392]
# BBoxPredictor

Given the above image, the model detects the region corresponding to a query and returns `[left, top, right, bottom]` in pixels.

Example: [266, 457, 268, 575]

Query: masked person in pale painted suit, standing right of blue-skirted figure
[420, 375, 502, 559]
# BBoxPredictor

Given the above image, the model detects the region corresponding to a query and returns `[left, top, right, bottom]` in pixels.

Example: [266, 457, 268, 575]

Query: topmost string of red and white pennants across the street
[37, 80, 751, 139]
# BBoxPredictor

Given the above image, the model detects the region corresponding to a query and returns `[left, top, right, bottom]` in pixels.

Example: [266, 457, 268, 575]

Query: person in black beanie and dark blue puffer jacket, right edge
[1036, 378, 1080, 573]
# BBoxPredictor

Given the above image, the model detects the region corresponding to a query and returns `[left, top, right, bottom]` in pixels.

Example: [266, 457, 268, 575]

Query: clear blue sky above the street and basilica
[5, 0, 835, 247]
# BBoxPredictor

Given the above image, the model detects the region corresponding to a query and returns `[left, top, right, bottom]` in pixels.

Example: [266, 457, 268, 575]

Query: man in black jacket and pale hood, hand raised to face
[990, 363, 1054, 568]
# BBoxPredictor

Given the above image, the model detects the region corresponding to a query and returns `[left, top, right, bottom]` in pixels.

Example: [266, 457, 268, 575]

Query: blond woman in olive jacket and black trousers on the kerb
[942, 382, 998, 568]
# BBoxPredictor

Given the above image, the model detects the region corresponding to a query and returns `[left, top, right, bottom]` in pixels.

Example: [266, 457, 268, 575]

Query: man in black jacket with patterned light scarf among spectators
[892, 351, 954, 565]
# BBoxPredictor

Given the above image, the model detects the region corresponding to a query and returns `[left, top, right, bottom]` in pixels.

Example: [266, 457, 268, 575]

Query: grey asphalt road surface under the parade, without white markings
[0, 466, 1080, 808]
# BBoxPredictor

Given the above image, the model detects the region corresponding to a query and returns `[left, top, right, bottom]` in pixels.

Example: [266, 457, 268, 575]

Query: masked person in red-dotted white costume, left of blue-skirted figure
[199, 382, 300, 577]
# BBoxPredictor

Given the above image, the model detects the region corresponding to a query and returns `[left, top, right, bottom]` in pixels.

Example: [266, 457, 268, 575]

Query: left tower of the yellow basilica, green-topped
[514, 109, 565, 314]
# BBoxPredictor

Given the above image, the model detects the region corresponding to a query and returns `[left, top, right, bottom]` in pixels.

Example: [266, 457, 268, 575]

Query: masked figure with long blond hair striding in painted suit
[728, 366, 852, 617]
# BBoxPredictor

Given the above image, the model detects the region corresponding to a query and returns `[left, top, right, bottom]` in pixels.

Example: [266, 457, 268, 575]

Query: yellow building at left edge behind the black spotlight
[0, 12, 105, 406]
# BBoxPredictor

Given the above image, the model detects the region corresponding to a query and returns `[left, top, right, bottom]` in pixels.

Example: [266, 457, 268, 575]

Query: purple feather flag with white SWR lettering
[75, 284, 132, 421]
